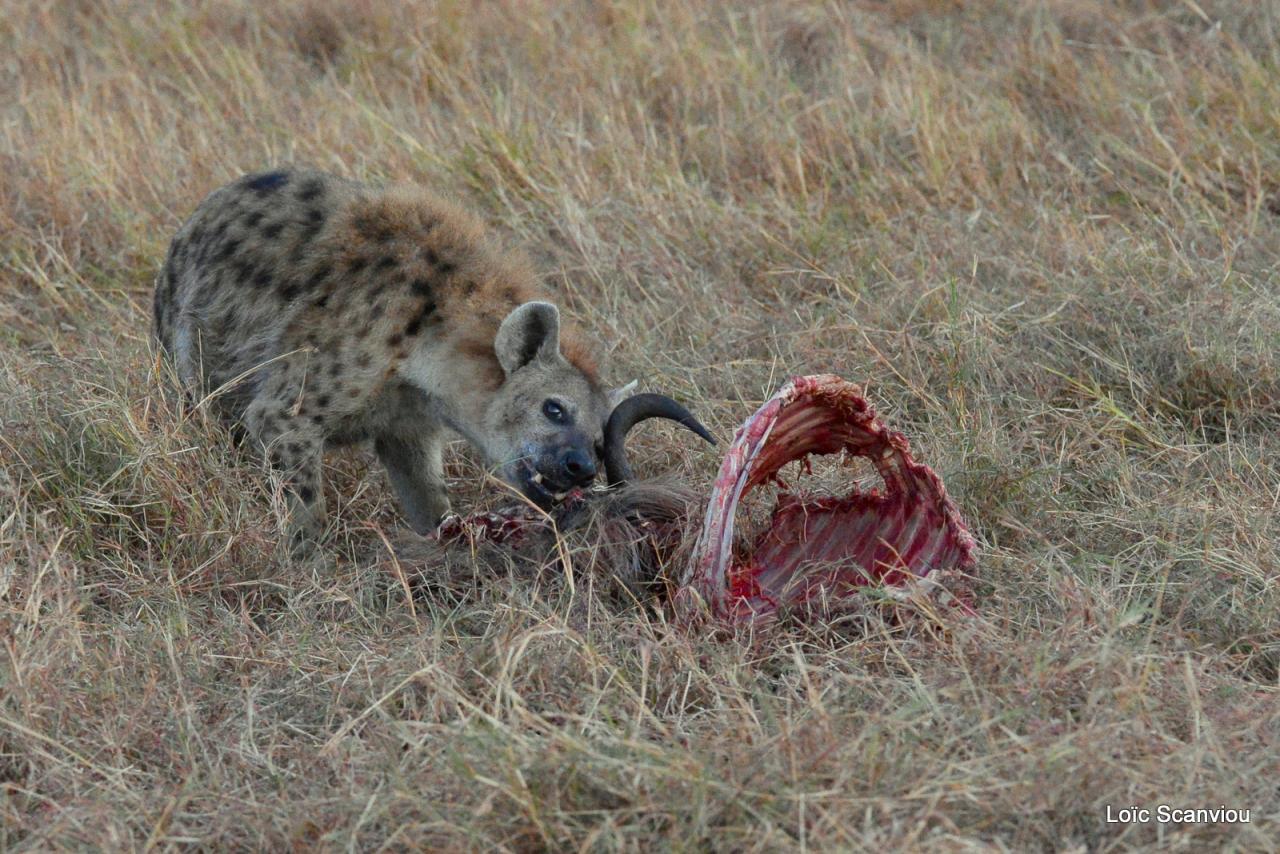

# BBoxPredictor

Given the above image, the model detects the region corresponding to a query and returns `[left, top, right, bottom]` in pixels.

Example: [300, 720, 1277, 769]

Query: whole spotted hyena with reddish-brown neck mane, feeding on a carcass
[155, 169, 616, 548]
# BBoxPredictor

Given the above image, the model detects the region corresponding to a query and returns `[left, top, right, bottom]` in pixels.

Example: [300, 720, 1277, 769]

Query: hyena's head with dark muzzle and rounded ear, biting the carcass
[484, 302, 617, 508]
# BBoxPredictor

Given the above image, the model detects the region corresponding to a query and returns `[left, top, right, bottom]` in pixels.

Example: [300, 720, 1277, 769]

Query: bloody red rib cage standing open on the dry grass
[680, 375, 974, 620]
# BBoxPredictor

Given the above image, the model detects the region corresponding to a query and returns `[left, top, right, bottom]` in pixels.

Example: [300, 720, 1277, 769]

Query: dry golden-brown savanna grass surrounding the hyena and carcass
[0, 0, 1280, 850]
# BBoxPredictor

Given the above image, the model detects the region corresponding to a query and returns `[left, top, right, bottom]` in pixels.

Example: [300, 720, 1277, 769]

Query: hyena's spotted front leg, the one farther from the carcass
[244, 398, 325, 556]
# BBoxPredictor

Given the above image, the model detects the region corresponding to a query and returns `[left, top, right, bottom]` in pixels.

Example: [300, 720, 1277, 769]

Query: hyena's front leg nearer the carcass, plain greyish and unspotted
[374, 421, 449, 534]
